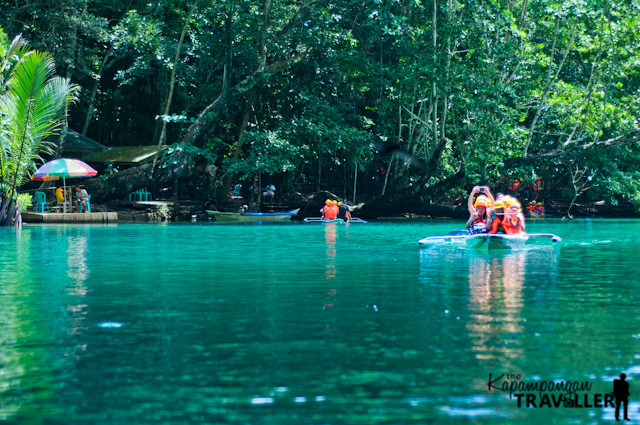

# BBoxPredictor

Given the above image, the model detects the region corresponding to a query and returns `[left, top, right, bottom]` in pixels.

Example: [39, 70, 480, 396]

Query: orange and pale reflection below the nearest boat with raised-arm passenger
[420, 248, 558, 370]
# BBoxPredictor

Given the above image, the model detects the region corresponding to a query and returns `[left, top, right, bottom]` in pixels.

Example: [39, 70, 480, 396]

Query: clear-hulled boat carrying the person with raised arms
[418, 232, 562, 249]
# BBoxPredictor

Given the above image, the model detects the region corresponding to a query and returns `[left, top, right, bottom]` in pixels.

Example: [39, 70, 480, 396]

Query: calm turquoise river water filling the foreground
[0, 220, 640, 424]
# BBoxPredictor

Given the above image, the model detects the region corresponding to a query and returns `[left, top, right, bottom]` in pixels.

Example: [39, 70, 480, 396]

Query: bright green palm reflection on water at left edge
[0, 231, 58, 424]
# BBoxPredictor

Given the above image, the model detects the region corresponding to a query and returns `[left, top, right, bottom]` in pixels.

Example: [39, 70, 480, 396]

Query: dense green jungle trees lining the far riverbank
[0, 0, 640, 212]
